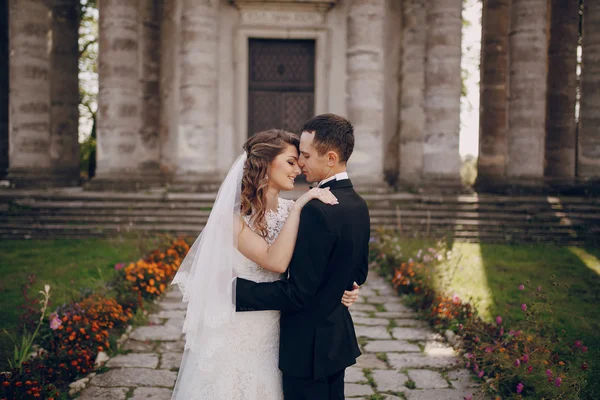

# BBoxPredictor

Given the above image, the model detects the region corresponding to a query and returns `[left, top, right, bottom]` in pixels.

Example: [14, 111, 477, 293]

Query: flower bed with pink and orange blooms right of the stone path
[370, 231, 589, 399]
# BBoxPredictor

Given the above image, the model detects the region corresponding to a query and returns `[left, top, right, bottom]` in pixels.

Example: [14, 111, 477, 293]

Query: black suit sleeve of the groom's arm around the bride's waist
[236, 200, 334, 311]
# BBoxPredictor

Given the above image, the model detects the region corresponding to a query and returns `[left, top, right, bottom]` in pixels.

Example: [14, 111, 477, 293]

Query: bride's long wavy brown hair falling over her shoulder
[241, 129, 300, 237]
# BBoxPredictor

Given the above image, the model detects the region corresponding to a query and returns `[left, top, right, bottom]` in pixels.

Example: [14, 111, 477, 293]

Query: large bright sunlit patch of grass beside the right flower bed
[435, 242, 494, 320]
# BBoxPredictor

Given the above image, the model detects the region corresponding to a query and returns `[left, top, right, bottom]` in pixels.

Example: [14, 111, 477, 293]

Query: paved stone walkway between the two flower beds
[79, 274, 482, 400]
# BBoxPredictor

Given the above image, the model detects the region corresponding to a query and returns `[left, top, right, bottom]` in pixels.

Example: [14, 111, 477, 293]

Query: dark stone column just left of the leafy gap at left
[49, 0, 79, 186]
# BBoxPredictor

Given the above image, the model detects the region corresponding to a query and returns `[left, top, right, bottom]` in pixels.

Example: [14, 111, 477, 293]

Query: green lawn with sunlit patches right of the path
[384, 239, 600, 399]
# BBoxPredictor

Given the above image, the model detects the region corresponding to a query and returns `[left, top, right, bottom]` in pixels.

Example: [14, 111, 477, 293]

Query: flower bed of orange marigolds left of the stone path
[0, 239, 189, 400]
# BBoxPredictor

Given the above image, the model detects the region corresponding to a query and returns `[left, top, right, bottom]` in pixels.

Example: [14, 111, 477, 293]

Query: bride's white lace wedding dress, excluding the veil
[175, 198, 294, 400]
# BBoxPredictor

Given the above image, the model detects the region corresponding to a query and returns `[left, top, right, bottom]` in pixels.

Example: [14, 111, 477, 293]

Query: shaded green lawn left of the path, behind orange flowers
[0, 236, 173, 371]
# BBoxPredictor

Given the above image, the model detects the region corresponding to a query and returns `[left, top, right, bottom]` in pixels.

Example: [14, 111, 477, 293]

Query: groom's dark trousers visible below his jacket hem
[282, 370, 345, 400]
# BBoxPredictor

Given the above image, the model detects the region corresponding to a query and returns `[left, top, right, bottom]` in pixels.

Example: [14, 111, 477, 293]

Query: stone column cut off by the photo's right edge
[577, 0, 600, 181]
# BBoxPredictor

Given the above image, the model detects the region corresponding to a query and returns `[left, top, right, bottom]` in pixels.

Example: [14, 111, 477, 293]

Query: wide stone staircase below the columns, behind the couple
[0, 188, 600, 245]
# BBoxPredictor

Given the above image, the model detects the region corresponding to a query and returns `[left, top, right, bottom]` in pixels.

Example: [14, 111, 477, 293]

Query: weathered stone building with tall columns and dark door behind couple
[0, 0, 600, 190]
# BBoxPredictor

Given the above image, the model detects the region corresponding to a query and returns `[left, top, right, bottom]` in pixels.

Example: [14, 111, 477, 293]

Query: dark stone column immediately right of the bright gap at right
[476, 0, 511, 190]
